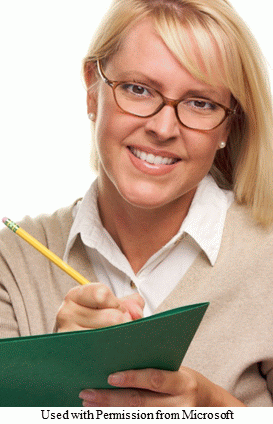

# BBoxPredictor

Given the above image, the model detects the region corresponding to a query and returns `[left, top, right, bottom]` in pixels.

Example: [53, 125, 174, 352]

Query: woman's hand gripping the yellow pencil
[55, 283, 144, 332]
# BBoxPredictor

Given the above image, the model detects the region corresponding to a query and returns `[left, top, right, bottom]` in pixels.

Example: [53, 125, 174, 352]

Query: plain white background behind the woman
[0, 0, 273, 222]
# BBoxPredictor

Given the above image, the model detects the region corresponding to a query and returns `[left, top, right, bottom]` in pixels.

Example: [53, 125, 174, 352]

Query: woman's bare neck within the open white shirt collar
[98, 177, 195, 273]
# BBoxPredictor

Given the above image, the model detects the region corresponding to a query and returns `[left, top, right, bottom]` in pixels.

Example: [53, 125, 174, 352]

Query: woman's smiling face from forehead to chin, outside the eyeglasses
[88, 21, 230, 209]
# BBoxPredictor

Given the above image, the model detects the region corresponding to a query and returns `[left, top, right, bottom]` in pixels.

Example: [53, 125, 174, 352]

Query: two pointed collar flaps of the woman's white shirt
[64, 175, 232, 265]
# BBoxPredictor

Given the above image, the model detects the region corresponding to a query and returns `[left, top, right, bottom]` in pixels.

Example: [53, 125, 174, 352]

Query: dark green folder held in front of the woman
[0, 303, 208, 407]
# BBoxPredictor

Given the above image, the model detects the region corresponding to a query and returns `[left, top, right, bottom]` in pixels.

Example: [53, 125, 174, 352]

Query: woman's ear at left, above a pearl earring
[84, 62, 98, 115]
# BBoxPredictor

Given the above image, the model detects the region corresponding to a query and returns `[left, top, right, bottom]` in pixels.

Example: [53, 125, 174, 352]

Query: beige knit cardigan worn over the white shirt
[0, 204, 273, 406]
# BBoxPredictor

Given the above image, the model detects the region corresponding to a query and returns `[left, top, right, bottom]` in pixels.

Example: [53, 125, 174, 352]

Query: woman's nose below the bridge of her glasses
[145, 105, 181, 141]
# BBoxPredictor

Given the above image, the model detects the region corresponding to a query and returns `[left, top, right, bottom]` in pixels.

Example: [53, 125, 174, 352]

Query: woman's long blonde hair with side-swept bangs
[83, 0, 273, 226]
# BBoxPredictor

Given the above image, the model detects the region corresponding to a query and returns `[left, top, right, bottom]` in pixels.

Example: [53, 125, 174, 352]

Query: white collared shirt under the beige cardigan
[64, 175, 234, 316]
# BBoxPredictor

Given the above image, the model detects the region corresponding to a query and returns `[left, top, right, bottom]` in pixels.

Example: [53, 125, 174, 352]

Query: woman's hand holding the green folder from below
[80, 366, 244, 407]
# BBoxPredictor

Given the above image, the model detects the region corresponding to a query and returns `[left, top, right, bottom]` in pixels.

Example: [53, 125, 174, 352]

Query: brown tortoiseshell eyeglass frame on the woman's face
[96, 59, 237, 131]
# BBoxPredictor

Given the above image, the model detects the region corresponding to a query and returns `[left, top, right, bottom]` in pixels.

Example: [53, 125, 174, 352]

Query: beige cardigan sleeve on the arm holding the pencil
[0, 205, 82, 338]
